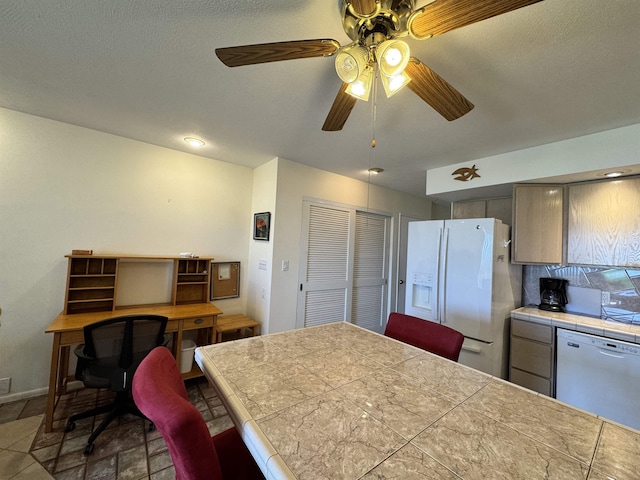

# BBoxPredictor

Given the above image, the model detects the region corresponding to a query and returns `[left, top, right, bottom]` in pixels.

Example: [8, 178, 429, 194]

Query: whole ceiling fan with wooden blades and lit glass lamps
[216, 0, 542, 131]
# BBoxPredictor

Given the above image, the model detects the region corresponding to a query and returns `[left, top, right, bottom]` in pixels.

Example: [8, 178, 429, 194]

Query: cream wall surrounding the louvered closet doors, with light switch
[268, 159, 431, 332]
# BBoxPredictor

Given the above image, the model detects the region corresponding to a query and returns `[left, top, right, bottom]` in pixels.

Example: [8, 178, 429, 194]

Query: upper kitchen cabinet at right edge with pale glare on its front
[567, 177, 640, 267]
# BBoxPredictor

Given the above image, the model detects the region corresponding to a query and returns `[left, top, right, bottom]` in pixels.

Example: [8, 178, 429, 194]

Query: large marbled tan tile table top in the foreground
[196, 322, 640, 480]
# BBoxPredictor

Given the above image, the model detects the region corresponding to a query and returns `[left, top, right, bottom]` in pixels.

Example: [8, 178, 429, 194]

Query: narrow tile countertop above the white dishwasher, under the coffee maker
[511, 307, 640, 344]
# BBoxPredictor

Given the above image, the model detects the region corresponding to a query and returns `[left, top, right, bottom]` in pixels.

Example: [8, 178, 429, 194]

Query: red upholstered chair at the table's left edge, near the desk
[133, 347, 264, 480]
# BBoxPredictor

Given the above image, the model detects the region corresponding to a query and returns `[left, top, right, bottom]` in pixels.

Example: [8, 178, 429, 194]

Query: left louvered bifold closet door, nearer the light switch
[297, 203, 352, 327]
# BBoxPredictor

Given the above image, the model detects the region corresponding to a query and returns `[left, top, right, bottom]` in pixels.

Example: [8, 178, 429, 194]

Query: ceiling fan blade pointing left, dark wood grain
[216, 38, 340, 67]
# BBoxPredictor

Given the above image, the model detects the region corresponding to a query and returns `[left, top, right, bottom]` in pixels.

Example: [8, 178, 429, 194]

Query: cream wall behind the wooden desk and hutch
[0, 109, 253, 401]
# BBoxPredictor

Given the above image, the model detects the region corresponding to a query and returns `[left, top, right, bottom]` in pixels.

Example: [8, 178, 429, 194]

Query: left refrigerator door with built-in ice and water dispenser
[404, 220, 444, 322]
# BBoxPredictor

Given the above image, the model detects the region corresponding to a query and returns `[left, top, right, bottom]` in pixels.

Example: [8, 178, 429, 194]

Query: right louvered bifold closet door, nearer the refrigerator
[351, 212, 389, 333]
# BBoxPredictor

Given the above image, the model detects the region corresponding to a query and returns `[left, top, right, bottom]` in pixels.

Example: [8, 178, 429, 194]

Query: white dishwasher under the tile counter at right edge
[556, 328, 640, 429]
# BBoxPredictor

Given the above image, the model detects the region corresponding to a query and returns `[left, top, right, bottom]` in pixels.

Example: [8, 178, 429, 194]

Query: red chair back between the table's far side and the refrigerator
[384, 312, 464, 362]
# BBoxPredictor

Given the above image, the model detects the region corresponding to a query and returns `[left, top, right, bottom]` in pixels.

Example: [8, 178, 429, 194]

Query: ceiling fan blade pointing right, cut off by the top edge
[409, 0, 542, 39]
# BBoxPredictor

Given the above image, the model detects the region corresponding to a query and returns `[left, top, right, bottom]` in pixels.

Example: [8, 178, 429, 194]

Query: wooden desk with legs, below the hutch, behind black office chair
[45, 303, 222, 432]
